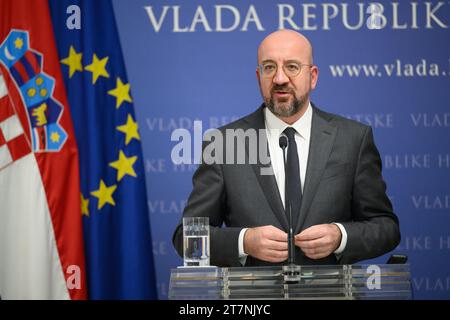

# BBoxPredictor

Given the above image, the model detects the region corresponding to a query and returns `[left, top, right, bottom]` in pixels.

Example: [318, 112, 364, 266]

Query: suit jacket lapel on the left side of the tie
[244, 107, 288, 230]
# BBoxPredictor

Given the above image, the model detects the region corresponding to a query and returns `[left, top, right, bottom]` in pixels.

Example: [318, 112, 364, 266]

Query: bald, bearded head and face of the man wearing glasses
[256, 32, 318, 117]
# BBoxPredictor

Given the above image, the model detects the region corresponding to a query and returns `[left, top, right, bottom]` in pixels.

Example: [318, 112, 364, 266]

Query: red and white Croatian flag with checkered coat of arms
[0, 0, 87, 299]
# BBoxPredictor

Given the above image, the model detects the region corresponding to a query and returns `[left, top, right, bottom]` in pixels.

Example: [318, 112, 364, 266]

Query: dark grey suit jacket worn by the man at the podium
[173, 105, 400, 266]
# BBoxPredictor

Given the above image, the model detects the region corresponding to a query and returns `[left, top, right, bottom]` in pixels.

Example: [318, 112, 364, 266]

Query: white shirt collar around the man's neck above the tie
[264, 102, 312, 140]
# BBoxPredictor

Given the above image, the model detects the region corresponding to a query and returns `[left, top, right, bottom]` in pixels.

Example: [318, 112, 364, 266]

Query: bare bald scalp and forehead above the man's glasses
[258, 29, 313, 65]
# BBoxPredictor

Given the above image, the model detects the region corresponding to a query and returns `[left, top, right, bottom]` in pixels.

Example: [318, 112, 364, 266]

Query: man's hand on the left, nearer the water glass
[244, 226, 288, 262]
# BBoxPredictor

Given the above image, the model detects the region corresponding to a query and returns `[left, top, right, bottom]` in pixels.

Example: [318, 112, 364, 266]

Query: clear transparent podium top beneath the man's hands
[169, 264, 412, 300]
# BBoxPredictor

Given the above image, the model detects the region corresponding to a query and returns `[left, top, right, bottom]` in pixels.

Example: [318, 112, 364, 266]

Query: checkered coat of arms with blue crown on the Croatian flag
[0, 30, 67, 170]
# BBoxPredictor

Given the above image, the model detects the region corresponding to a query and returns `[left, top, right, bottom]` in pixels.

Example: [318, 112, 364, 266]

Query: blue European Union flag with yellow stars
[50, 0, 156, 299]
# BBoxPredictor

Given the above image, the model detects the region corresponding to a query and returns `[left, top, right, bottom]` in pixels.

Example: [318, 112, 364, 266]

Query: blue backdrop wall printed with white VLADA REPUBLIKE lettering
[110, 0, 450, 299]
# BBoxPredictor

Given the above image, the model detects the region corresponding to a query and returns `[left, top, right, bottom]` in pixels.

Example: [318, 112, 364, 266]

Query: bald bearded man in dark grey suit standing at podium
[173, 30, 400, 266]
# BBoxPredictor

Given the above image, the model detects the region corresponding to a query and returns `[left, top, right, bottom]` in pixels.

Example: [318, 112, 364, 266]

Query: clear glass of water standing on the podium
[183, 217, 209, 267]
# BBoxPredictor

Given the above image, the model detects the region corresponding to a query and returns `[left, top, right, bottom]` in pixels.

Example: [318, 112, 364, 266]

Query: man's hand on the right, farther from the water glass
[295, 224, 342, 259]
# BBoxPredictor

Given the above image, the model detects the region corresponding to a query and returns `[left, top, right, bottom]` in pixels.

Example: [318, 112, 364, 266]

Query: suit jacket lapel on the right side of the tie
[294, 107, 337, 234]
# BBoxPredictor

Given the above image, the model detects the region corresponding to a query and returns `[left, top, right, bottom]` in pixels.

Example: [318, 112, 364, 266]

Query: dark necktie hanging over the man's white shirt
[283, 127, 302, 230]
